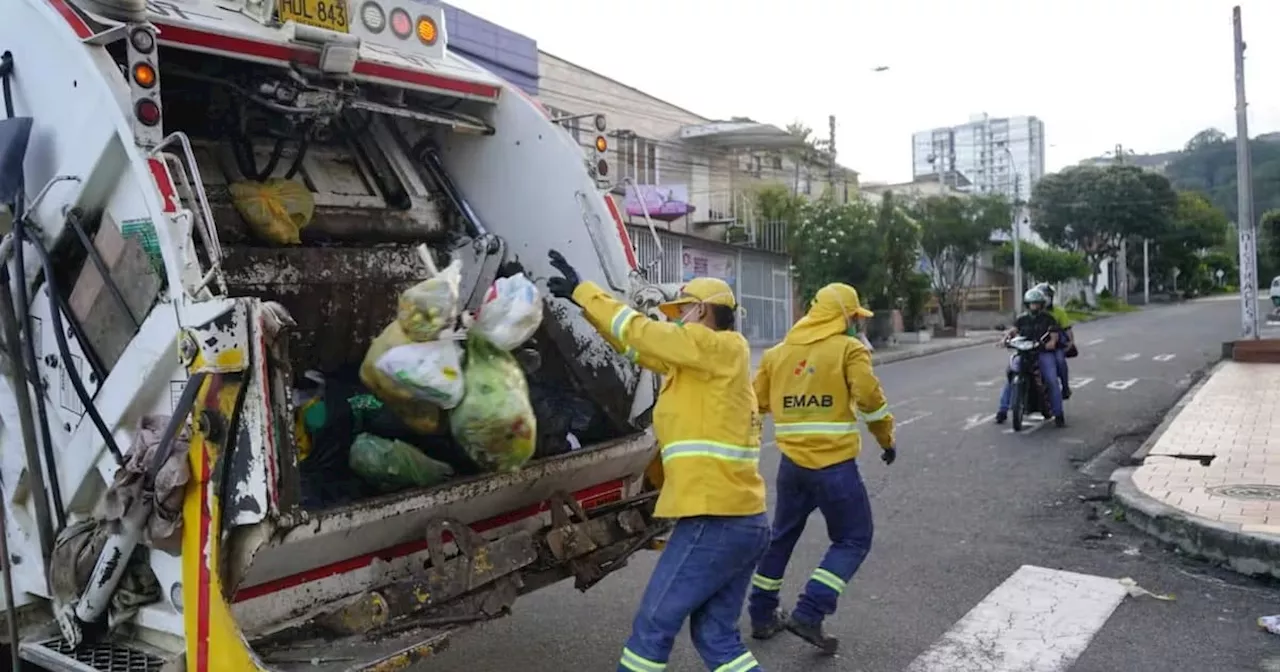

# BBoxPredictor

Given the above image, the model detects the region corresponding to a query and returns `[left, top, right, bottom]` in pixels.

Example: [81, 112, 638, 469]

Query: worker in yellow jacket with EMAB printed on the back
[749, 283, 897, 653]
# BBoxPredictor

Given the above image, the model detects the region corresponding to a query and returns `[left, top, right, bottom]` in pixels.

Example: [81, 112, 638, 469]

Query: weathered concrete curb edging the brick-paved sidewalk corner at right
[1111, 467, 1280, 579]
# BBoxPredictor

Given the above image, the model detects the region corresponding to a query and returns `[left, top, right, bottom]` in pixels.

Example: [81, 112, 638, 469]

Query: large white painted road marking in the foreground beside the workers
[906, 564, 1128, 672]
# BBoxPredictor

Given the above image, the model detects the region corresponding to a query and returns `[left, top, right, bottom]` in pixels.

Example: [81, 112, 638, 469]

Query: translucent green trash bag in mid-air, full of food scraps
[449, 335, 538, 472]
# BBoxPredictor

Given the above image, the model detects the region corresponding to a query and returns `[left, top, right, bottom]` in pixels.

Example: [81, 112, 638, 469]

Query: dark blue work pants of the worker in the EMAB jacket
[748, 454, 873, 625]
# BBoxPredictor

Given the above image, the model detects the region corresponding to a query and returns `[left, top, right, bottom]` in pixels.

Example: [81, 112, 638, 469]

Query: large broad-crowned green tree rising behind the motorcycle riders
[1030, 165, 1178, 285]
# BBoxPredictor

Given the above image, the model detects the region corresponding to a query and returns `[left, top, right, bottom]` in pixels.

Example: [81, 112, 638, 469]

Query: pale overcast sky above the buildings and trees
[451, 0, 1280, 180]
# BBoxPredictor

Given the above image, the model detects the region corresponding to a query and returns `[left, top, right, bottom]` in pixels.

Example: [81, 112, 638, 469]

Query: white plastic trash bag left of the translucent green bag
[376, 340, 466, 410]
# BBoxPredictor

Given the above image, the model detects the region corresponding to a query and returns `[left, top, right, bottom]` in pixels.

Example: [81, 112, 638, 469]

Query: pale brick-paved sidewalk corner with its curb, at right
[1111, 361, 1280, 577]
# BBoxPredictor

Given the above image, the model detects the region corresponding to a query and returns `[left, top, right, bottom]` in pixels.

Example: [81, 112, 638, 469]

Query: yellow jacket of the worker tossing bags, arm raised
[573, 282, 765, 518]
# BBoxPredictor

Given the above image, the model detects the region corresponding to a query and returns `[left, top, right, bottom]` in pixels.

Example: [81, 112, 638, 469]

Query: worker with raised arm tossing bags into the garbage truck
[547, 251, 769, 672]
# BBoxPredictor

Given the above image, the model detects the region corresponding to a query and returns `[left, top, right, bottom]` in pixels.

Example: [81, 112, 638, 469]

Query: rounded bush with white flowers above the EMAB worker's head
[790, 190, 882, 303]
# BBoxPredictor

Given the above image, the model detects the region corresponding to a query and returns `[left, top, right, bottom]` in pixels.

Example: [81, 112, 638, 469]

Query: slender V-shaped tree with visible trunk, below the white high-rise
[915, 195, 1012, 326]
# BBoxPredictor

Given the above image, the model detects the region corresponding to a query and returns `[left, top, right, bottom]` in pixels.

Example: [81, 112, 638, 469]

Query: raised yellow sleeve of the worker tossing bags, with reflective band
[573, 282, 714, 370]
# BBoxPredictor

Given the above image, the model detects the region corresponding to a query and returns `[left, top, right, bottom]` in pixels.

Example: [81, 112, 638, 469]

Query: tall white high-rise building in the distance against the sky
[911, 114, 1044, 200]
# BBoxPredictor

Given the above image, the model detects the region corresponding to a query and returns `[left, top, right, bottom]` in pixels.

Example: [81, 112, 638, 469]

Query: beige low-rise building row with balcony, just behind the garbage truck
[536, 51, 856, 344]
